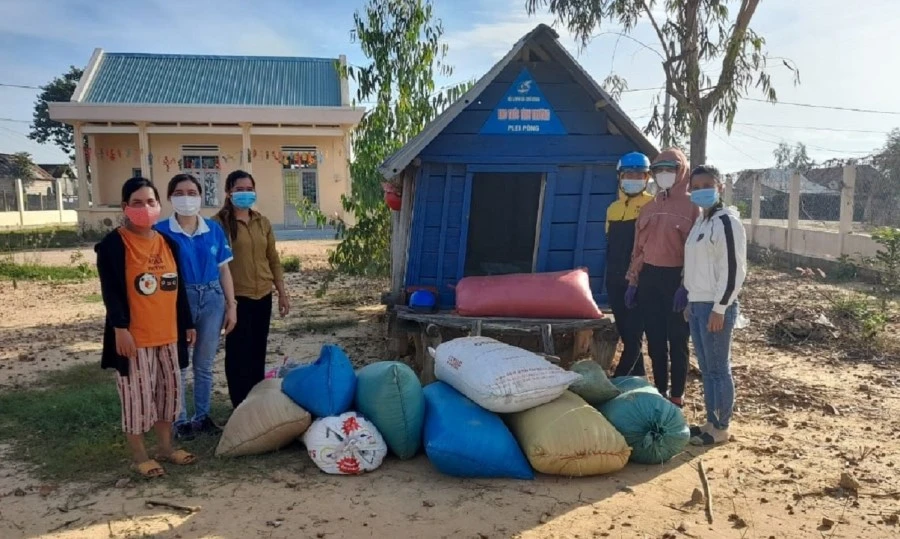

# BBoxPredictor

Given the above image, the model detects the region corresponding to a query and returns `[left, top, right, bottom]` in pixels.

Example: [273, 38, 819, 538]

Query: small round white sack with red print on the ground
[303, 412, 387, 475]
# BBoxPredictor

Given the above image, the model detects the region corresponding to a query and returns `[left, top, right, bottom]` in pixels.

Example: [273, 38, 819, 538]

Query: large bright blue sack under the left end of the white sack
[425, 382, 534, 479]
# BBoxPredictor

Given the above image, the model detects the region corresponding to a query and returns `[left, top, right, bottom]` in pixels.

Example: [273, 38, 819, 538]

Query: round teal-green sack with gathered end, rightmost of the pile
[597, 390, 691, 464]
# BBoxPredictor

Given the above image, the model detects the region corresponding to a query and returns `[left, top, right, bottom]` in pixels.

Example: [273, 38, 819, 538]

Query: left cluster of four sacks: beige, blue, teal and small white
[216, 344, 425, 475]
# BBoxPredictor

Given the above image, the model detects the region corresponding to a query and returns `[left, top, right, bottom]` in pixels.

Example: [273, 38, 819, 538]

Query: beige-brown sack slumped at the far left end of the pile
[216, 378, 312, 457]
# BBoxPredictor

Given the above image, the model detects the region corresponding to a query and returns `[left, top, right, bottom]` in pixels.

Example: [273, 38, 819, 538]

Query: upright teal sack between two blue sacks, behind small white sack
[356, 361, 425, 459]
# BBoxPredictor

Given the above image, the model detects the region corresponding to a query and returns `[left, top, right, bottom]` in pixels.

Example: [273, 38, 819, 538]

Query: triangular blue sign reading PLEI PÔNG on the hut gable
[481, 69, 567, 135]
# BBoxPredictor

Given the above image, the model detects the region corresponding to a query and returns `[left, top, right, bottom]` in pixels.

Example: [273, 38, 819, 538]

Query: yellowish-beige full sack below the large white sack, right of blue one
[506, 391, 631, 477]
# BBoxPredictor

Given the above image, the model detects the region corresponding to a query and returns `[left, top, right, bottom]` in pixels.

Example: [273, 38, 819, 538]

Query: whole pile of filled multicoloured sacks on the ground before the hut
[216, 337, 689, 479]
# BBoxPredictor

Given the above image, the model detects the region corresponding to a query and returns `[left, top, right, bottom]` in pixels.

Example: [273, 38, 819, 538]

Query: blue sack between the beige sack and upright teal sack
[281, 344, 356, 417]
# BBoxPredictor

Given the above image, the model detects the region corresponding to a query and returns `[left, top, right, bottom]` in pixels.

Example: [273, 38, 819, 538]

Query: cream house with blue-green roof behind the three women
[50, 49, 364, 228]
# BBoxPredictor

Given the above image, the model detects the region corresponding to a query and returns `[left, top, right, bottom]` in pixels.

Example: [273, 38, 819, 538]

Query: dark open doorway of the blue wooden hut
[464, 172, 544, 276]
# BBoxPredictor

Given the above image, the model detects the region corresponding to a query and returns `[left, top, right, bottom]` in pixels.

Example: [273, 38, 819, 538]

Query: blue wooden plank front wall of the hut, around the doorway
[405, 62, 637, 306]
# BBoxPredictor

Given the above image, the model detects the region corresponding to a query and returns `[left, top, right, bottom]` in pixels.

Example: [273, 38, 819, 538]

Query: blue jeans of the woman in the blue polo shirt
[175, 281, 225, 425]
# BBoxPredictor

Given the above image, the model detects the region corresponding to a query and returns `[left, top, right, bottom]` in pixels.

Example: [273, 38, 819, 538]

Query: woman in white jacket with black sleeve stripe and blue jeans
[684, 165, 747, 445]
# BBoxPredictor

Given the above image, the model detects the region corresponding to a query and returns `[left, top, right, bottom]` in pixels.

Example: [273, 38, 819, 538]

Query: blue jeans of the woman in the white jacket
[689, 302, 738, 429]
